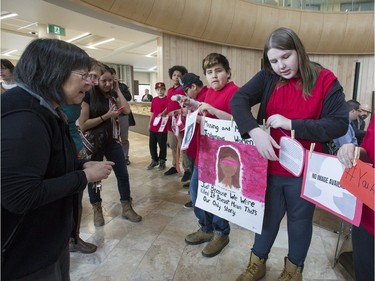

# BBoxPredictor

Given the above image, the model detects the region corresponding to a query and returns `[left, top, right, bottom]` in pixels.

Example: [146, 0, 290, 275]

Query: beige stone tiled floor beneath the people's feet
[71, 132, 352, 281]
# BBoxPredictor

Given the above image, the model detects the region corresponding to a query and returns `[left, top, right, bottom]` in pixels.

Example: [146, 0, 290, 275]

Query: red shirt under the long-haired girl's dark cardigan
[266, 69, 336, 177]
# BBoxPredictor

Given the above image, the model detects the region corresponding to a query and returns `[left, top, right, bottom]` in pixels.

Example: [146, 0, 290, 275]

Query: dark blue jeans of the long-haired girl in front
[252, 175, 315, 266]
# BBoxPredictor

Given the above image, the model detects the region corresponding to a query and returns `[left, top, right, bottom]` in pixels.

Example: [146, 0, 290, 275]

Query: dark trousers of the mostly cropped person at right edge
[352, 222, 374, 281]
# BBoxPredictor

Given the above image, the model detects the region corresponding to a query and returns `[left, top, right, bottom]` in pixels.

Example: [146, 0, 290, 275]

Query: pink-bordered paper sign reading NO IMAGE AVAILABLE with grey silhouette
[301, 152, 362, 226]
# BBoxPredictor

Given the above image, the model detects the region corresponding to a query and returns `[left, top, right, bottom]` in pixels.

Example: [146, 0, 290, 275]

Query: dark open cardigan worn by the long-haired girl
[230, 70, 349, 143]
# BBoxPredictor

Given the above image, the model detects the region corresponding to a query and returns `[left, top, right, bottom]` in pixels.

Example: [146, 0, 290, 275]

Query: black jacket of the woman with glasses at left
[1, 87, 87, 280]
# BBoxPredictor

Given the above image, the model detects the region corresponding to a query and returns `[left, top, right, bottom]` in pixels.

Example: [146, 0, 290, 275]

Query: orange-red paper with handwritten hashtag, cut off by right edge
[340, 160, 375, 210]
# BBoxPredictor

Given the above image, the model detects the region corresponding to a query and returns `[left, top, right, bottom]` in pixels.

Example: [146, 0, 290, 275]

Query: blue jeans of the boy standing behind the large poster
[189, 165, 230, 236]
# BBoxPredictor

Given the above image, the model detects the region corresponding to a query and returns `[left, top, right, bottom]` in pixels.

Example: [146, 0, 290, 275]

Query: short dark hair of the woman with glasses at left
[14, 39, 91, 105]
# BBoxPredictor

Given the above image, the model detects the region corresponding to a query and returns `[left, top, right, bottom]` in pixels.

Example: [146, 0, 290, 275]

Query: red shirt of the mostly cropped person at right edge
[361, 118, 375, 236]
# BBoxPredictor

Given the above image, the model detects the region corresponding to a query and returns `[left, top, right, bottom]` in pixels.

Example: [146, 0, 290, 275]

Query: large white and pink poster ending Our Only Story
[196, 117, 268, 233]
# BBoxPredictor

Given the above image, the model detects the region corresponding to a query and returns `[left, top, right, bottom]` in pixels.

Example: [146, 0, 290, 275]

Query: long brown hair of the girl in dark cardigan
[263, 27, 323, 97]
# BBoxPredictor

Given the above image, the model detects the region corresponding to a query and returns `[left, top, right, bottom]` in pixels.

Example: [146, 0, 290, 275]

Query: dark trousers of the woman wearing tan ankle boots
[88, 141, 130, 204]
